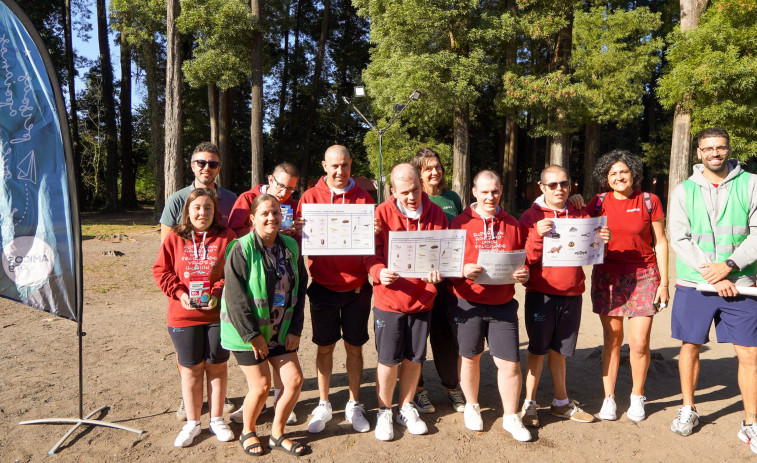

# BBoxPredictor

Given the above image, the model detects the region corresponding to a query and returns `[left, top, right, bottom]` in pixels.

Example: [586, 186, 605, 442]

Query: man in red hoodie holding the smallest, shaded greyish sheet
[449, 170, 531, 442]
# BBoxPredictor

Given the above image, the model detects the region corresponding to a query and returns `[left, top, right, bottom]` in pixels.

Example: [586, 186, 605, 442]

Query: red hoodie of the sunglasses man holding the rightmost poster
[520, 196, 591, 296]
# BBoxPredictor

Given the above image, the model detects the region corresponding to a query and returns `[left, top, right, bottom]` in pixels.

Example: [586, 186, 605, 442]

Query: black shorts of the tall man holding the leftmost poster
[308, 281, 373, 346]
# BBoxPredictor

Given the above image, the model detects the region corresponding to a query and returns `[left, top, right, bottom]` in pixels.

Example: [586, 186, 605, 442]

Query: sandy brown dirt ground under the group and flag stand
[0, 211, 757, 462]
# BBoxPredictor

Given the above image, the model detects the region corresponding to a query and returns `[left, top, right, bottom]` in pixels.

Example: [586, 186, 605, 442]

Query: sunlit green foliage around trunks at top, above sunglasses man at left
[176, 0, 259, 90]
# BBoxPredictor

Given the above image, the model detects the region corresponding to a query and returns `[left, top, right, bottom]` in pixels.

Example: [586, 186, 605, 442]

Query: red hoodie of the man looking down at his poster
[365, 193, 449, 313]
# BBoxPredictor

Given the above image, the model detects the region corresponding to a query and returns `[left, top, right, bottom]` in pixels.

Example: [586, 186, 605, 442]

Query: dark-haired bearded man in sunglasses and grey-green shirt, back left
[160, 142, 237, 243]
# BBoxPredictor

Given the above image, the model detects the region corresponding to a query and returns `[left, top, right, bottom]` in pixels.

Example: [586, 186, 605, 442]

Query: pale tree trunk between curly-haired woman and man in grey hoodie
[668, 0, 708, 210]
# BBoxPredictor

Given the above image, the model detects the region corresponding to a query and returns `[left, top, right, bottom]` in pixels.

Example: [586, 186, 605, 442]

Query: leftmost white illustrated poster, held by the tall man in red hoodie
[302, 204, 376, 256]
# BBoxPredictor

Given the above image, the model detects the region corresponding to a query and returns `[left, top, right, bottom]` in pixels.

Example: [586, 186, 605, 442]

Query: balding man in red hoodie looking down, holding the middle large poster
[365, 164, 448, 441]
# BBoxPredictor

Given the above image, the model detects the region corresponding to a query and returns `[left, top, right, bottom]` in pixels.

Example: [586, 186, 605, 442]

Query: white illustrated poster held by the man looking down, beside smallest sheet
[388, 230, 465, 278]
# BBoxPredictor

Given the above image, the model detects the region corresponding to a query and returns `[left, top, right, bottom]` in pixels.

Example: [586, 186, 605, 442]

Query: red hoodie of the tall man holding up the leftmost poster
[294, 177, 374, 291]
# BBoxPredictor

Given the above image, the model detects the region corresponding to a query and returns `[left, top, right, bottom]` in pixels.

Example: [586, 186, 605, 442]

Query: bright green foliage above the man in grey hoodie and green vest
[658, 0, 757, 159]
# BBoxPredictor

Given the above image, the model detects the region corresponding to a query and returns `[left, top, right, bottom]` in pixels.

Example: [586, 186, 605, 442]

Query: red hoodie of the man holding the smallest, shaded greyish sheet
[450, 203, 525, 305]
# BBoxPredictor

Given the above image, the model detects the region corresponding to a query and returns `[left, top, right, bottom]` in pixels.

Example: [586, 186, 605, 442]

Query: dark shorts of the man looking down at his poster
[373, 307, 431, 366]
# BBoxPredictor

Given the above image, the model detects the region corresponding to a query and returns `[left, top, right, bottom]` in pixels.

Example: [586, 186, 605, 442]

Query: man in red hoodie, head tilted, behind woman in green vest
[229, 162, 300, 238]
